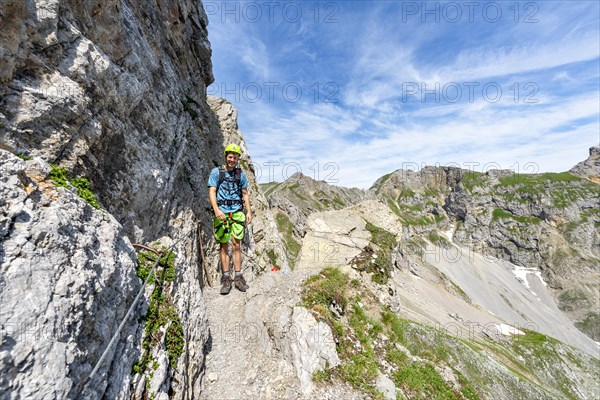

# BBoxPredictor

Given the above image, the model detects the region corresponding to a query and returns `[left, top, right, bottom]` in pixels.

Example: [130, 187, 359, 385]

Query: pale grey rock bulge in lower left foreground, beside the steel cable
[0, 150, 140, 399]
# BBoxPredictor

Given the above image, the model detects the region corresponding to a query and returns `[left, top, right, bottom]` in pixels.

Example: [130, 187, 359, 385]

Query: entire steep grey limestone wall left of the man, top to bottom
[0, 0, 283, 399]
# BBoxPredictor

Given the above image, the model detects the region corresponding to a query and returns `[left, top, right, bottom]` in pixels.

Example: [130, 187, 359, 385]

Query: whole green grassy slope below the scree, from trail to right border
[302, 268, 600, 400]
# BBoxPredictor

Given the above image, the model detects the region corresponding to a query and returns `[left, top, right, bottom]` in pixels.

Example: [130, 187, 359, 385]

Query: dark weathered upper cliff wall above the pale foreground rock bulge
[0, 0, 216, 241]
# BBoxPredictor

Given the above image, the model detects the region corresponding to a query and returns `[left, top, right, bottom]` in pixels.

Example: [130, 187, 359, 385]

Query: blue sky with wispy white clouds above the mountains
[204, 0, 600, 188]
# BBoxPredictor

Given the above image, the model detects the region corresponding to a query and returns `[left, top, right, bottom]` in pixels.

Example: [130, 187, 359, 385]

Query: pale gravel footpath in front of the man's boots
[201, 272, 298, 400]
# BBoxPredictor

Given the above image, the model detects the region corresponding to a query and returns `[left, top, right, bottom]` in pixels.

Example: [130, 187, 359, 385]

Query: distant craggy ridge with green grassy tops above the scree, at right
[372, 148, 600, 340]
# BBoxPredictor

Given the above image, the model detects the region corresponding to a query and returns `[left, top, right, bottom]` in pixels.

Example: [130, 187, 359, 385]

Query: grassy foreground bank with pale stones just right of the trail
[302, 268, 479, 399]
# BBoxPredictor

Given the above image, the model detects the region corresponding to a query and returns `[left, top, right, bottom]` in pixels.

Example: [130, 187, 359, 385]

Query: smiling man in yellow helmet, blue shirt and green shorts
[208, 143, 252, 294]
